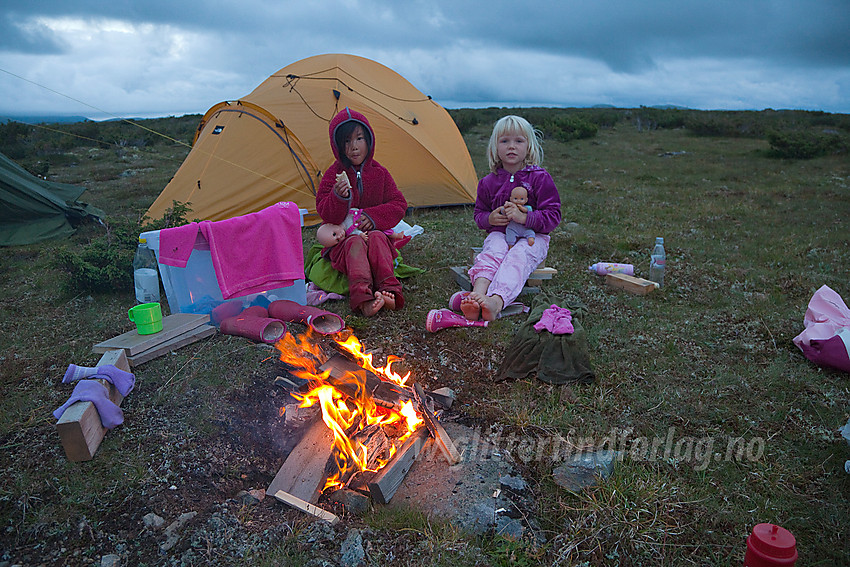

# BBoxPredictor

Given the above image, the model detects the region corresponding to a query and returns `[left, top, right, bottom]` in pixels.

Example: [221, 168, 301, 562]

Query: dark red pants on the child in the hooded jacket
[328, 230, 404, 311]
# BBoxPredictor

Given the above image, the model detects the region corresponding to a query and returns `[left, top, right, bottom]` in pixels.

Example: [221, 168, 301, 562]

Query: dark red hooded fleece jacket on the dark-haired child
[316, 108, 407, 230]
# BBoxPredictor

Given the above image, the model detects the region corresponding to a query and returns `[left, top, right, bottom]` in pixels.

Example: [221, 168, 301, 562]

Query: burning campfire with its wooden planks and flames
[268, 330, 460, 521]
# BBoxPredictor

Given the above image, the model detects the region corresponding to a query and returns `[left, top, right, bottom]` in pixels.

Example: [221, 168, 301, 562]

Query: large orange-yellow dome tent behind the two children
[148, 54, 477, 221]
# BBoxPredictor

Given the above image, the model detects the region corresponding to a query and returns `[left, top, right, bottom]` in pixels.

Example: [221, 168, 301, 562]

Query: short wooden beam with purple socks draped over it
[56, 349, 130, 462]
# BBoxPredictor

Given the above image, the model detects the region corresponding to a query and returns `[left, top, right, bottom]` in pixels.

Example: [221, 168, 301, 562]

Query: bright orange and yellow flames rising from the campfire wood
[275, 330, 423, 489]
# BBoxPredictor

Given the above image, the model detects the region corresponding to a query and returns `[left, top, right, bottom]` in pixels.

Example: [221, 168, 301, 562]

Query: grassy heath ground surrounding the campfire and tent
[0, 108, 850, 565]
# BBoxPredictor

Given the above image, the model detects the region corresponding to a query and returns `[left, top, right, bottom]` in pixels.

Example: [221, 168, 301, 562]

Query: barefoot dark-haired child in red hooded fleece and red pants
[316, 108, 407, 317]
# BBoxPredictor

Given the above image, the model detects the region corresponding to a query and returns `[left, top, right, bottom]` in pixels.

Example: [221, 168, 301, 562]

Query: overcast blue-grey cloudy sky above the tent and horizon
[0, 0, 850, 119]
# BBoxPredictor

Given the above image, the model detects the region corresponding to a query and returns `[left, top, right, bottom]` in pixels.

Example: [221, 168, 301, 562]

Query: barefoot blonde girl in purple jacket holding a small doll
[460, 116, 561, 321]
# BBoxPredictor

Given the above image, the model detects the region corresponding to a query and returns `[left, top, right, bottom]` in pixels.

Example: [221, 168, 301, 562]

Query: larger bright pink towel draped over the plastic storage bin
[200, 202, 304, 299]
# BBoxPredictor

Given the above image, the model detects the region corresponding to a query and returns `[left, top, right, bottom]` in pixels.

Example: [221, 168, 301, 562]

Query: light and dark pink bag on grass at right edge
[793, 286, 850, 372]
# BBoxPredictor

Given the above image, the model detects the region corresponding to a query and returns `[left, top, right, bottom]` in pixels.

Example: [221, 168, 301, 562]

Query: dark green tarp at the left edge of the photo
[0, 154, 103, 246]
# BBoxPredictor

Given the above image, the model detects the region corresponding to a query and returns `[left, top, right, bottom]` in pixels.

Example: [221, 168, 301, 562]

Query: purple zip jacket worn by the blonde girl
[474, 165, 561, 234]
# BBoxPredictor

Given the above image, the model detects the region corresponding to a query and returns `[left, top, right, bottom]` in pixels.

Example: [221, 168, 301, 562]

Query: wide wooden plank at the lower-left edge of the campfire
[266, 414, 334, 504]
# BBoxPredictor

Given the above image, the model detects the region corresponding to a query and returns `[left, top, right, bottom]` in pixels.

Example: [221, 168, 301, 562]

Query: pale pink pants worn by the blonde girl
[468, 232, 549, 305]
